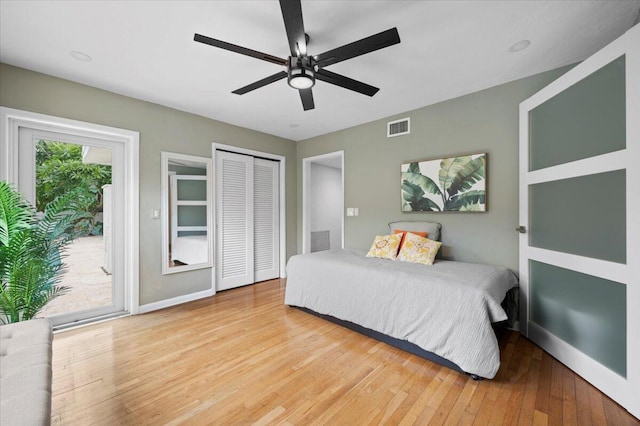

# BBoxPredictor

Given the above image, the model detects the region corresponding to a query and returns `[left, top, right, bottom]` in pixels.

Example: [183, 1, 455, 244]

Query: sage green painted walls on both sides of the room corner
[0, 60, 569, 304]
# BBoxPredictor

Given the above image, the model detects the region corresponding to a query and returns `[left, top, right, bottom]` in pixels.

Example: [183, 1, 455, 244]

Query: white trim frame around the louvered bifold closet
[211, 142, 287, 294]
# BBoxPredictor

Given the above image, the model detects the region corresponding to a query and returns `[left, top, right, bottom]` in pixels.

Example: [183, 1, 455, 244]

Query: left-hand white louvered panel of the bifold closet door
[216, 151, 254, 290]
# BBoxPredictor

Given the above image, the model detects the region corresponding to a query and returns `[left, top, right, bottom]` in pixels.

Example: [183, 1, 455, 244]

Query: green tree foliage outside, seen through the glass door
[36, 140, 111, 234]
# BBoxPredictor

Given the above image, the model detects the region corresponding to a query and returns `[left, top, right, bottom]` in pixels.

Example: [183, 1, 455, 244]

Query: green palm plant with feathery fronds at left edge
[0, 181, 86, 323]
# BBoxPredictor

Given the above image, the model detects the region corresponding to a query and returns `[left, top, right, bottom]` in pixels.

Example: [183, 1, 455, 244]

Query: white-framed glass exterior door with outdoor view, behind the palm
[0, 108, 139, 329]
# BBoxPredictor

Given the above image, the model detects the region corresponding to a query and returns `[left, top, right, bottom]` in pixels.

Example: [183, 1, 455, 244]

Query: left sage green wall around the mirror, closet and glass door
[0, 64, 296, 305]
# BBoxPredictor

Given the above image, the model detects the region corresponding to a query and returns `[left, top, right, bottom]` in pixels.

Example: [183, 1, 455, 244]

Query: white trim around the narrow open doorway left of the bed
[302, 150, 344, 253]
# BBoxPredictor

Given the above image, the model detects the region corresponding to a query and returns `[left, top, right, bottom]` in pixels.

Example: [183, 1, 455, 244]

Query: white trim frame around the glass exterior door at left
[0, 107, 140, 314]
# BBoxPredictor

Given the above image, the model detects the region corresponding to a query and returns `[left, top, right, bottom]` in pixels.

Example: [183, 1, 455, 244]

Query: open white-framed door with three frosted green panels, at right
[516, 25, 640, 423]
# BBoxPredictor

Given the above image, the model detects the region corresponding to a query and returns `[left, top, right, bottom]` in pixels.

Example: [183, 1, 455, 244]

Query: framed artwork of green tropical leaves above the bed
[400, 153, 487, 212]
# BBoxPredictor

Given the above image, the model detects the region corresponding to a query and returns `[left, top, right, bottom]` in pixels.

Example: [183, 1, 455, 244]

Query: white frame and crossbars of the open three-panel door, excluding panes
[519, 22, 640, 417]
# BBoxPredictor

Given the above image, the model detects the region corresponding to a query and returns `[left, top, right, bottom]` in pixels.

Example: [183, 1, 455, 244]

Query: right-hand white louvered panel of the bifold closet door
[253, 158, 280, 281]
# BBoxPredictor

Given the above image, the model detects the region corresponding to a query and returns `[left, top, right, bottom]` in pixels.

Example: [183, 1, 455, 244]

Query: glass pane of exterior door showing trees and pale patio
[35, 138, 114, 318]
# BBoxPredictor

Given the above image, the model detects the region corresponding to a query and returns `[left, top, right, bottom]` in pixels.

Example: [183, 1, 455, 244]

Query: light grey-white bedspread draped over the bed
[285, 250, 517, 378]
